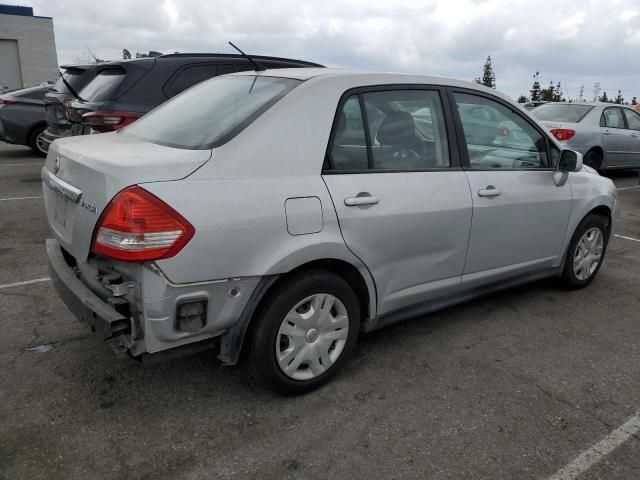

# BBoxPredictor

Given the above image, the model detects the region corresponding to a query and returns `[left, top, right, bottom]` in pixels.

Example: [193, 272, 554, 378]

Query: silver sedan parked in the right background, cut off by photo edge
[531, 102, 640, 171]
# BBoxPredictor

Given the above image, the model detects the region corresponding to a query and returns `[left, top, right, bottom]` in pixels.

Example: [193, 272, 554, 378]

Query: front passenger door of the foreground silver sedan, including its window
[452, 91, 572, 288]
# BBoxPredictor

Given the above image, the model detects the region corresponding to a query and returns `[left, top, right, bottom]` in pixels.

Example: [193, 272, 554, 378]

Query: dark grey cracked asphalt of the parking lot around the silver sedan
[0, 144, 640, 480]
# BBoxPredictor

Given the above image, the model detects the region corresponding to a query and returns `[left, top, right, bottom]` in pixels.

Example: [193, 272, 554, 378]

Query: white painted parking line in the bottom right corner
[547, 414, 640, 480]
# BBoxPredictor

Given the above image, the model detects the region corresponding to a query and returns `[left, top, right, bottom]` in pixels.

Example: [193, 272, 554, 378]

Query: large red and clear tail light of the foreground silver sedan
[92, 186, 195, 262]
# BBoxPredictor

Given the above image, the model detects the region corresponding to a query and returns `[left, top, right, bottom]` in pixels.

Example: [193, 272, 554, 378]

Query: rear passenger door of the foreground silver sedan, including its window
[323, 86, 471, 314]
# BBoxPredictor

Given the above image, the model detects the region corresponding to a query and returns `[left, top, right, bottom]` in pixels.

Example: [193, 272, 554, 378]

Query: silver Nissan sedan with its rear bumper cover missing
[42, 68, 618, 394]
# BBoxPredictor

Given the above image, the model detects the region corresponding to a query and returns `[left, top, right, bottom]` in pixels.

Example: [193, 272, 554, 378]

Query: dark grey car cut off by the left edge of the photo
[0, 84, 53, 157]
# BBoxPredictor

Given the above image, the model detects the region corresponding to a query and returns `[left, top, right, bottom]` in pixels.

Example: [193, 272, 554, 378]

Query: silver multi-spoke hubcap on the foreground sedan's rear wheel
[276, 293, 349, 380]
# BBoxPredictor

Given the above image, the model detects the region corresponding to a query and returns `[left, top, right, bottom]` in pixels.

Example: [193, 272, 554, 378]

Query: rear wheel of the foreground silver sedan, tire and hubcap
[248, 271, 360, 395]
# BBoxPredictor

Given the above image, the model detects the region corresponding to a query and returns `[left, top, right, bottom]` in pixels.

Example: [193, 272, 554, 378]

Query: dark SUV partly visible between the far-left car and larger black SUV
[42, 64, 97, 150]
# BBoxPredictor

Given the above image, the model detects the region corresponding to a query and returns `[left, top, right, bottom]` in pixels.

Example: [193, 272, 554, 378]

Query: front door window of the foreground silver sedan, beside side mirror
[454, 93, 549, 170]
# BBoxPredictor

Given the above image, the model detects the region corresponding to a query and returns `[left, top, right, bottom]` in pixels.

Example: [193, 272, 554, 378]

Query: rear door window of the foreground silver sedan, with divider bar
[329, 90, 451, 171]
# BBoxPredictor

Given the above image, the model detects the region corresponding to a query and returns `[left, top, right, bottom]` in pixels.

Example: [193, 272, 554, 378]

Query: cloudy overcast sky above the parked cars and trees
[28, 0, 640, 100]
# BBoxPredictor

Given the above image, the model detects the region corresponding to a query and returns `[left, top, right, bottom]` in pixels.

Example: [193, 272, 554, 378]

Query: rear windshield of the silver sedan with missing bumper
[123, 75, 301, 149]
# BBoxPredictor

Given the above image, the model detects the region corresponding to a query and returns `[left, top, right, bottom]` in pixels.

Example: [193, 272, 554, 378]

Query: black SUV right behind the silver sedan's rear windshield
[68, 53, 322, 135]
